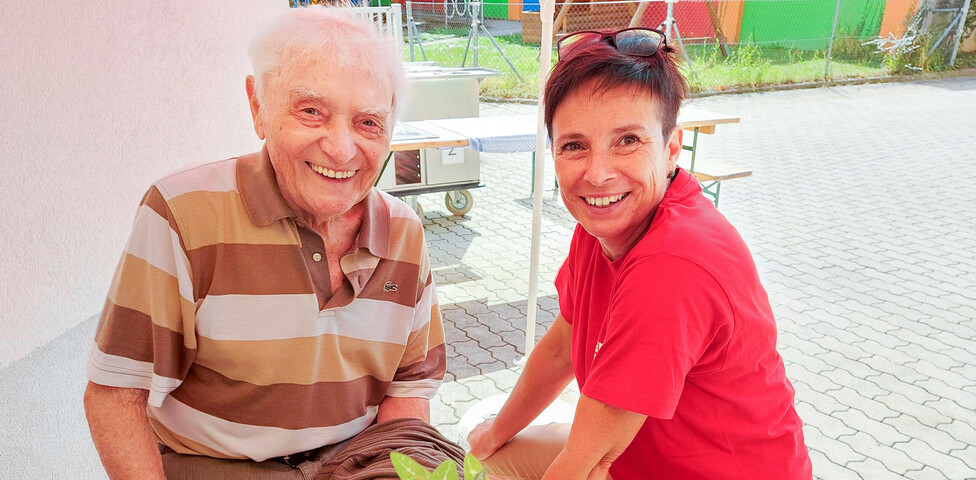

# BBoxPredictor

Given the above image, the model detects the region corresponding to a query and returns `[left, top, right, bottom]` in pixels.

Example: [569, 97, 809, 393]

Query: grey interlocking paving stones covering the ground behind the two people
[419, 77, 976, 480]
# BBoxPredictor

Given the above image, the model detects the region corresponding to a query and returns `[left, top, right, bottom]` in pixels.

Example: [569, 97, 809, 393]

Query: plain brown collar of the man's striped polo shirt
[237, 147, 390, 258]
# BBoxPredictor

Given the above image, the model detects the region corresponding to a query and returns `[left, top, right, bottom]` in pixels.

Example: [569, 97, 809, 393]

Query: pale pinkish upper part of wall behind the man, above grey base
[0, 0, 288, 368]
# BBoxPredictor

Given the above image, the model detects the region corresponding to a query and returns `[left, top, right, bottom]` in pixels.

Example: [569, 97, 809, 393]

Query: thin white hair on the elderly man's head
[249, 7, 406, 118]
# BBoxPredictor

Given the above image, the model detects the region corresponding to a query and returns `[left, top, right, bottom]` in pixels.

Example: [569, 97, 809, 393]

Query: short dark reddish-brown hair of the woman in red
[545, 40, 688, 138]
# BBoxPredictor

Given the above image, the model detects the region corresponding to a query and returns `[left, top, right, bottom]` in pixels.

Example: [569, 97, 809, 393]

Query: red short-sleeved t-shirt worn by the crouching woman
[556, 171, 813, 480]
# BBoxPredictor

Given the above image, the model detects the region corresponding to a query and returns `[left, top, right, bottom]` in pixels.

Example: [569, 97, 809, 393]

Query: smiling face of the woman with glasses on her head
[552, 82, 681, 260]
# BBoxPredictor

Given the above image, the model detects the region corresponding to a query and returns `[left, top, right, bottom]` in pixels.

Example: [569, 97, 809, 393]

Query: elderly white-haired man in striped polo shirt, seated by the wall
[85, 8, 461, 479]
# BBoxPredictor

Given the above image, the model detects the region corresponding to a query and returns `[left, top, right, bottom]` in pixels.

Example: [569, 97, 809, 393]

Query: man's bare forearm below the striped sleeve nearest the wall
[85, 382, 166, 480]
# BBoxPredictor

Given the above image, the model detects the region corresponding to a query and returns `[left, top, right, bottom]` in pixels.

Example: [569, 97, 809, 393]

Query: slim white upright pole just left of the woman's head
[525, 0, 556, 358]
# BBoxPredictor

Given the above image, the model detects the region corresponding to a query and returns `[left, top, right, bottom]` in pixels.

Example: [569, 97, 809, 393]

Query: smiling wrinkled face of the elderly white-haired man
[248, 54, 394, 224]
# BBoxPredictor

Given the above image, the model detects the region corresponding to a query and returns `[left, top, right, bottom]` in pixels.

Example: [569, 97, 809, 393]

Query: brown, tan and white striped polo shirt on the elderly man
[87, 151, 446, 461]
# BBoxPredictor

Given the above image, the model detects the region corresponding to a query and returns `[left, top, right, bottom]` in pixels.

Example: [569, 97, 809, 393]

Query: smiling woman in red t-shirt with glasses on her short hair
[468, 28, 812, 480]
